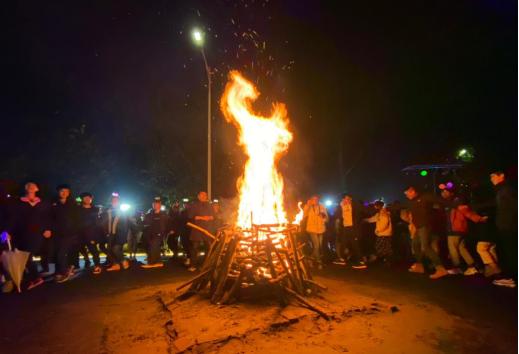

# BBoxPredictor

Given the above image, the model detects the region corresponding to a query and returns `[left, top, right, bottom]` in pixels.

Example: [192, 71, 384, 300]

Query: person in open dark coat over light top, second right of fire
[335, 194, 367, 269]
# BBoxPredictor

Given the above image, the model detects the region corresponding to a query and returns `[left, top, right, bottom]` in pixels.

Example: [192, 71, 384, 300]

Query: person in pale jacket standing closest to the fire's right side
[303, 195, 328, 269]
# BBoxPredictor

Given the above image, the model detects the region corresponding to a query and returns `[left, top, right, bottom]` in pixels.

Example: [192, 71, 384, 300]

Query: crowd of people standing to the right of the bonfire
[301, 167, 518, 288]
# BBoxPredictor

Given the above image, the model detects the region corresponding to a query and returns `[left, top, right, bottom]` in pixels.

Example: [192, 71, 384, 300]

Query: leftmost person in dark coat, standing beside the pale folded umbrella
[6, 182, 52, 290]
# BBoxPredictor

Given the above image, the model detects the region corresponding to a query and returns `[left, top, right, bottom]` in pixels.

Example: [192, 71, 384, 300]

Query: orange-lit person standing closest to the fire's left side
[188, 192, 214, 271]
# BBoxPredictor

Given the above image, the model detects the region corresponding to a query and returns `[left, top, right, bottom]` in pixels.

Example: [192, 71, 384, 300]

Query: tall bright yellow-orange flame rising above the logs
[220, 71, 292, 228]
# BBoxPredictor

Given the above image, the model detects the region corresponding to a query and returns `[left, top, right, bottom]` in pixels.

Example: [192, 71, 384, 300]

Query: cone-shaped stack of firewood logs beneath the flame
[177, 224, 327, 317]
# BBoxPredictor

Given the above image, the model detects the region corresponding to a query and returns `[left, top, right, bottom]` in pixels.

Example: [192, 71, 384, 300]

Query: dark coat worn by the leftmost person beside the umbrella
[7, 198, 51, 253]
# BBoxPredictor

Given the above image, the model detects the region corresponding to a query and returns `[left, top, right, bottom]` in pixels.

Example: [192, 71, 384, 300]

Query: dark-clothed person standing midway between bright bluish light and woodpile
[142, 197, 169, 269]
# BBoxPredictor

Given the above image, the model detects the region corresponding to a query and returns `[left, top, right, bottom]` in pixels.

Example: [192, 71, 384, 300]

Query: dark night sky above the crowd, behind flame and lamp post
[0, 0, 518, 205]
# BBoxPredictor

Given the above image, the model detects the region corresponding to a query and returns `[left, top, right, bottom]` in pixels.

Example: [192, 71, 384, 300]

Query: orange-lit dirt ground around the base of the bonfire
[4, 268, 517, 354]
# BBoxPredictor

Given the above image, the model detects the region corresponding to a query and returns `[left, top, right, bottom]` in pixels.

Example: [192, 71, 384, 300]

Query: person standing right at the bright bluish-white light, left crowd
[101, 193, 130, 272]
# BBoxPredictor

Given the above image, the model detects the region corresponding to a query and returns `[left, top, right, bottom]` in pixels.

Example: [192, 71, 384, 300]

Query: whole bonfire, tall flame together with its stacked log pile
[177, 71, 327, 318]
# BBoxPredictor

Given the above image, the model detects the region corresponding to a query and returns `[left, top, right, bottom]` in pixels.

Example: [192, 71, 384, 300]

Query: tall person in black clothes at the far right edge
[490, 170, 517, 288]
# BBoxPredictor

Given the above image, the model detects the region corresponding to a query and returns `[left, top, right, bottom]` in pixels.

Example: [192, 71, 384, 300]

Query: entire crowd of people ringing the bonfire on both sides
[0, 167, 518, 292]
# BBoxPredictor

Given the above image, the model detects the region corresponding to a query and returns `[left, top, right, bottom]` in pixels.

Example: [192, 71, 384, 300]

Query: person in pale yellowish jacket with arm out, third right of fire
[365, 200, 393, 263]
